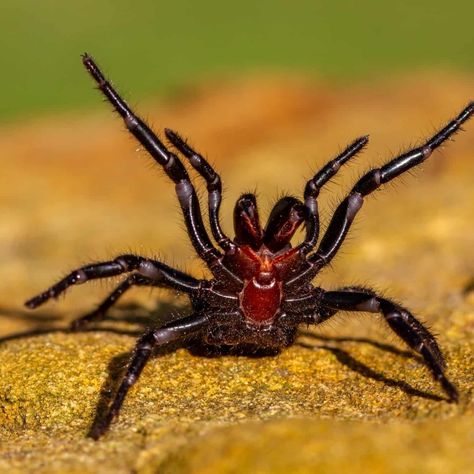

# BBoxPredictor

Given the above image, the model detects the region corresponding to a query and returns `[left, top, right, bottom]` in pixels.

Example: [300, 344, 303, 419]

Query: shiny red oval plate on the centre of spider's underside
[240, 273, 281, 324]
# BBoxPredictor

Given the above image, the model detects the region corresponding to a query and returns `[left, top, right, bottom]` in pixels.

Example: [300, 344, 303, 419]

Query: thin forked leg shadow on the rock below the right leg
[296, 332, 445, 402]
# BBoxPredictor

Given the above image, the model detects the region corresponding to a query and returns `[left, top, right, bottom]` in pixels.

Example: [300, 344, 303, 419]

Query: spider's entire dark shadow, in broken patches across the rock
[0, 303, 444, 436]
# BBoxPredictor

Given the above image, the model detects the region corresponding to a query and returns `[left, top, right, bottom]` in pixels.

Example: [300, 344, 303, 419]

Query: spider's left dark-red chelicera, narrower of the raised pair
[234, 194, 263, 250]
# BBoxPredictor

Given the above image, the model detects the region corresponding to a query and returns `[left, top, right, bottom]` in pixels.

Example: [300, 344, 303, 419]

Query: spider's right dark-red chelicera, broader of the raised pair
[264, 197, 306, 252]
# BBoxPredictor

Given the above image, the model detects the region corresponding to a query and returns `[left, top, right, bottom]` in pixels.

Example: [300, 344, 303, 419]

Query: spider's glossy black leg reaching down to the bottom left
[89, 314, 208, 439]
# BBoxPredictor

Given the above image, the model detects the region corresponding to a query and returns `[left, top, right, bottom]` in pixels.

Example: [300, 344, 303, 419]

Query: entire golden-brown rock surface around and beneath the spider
[0, 72, 474, 474]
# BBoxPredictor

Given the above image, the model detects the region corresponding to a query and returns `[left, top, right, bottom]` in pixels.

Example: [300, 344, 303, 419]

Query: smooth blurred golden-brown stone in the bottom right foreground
[158, 418, 474, 474]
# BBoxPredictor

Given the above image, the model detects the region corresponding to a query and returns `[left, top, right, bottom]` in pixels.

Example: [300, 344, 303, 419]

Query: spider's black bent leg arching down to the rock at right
[320, 288, 458, 402]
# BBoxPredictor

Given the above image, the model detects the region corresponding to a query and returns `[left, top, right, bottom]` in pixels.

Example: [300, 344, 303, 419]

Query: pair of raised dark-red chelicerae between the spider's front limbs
[234, 194, 306, 253]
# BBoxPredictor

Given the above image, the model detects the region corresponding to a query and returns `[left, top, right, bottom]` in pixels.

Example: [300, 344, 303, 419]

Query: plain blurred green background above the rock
[0, 0, 474, 122]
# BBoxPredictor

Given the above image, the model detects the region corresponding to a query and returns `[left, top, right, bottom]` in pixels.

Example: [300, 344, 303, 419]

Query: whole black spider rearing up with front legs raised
[25, 54, 474, 439]
